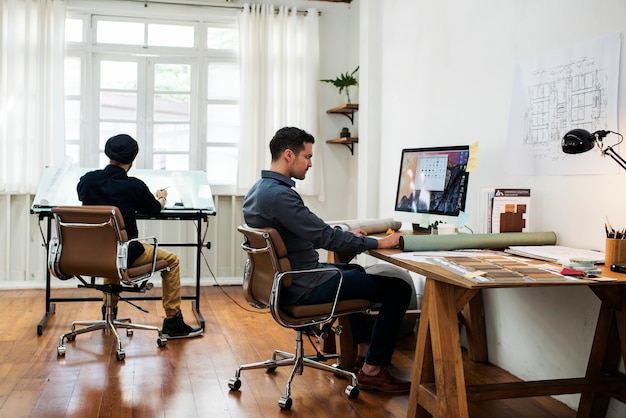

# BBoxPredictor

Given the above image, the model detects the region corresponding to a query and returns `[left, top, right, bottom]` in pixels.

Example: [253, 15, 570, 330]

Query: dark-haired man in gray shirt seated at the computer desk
[243, 127, 412, 392]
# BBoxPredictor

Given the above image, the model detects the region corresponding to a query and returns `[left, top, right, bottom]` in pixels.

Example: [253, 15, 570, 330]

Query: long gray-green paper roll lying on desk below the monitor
[400, 232, 556, 251]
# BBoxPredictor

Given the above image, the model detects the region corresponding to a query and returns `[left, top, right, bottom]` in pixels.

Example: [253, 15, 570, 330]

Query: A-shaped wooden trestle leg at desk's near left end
[407, 278, 471, 418]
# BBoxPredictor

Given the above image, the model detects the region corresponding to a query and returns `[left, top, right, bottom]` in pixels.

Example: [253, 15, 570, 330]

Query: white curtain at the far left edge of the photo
[0, 0, 65, 193]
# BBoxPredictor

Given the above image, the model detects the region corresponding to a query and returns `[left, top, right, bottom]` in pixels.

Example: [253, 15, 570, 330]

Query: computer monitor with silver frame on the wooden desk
[394, 145, 469, 230]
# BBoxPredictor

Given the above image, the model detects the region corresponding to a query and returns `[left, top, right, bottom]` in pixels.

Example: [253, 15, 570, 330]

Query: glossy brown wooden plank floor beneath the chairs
[0, 286, 575, 418]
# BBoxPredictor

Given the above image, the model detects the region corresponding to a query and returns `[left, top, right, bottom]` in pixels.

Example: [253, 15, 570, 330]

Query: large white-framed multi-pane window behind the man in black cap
[65, 9, 240, 190]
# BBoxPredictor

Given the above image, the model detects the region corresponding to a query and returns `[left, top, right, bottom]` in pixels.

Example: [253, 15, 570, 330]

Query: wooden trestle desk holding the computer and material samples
[369, 250, 626, 418]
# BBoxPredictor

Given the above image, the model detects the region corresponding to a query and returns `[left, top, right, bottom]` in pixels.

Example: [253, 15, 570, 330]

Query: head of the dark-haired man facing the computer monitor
[270, 127, 315, 180]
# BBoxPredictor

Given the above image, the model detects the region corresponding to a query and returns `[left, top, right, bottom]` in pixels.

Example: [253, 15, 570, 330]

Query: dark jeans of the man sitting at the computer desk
[298, 265, 412, 366]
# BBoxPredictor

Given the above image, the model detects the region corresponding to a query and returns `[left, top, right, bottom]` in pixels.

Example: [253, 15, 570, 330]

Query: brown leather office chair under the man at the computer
[228, 225, 371, 410]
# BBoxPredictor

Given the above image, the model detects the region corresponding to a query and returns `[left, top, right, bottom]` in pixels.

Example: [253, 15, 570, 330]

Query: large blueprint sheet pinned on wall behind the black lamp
[505, 34, 621, 175]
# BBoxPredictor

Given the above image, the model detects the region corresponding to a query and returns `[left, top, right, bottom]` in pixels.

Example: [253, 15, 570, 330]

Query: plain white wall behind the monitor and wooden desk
[366, 0, 626, 417]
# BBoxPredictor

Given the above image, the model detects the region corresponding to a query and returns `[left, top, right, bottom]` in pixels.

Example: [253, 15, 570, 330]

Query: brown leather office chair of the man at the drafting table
[48, 206, 169, 360]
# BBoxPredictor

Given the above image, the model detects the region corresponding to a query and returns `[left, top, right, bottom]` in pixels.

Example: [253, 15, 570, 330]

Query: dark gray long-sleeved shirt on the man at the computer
[243, 170, 378, 303]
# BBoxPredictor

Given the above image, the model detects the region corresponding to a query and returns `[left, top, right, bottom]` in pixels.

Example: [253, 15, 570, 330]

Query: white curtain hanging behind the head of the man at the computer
[237, 4, 324, 201]
